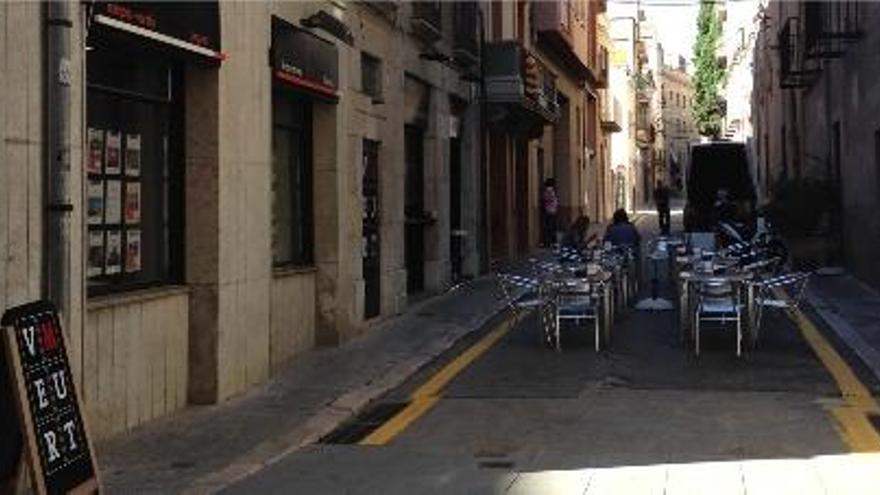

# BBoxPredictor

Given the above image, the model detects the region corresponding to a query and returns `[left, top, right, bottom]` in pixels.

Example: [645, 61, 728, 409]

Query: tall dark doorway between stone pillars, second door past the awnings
[403, 125, 429, 294]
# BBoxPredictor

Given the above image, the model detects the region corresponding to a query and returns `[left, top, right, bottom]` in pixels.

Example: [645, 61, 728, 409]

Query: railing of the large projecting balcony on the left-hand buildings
[484, 40, 559, 128]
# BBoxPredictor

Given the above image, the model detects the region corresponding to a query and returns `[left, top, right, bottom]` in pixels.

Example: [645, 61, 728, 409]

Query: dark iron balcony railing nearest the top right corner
[803, 0, 862, 58]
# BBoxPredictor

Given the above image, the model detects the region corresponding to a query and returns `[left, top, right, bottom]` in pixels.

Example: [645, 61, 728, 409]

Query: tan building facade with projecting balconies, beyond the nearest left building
[483, 0, 609, 260]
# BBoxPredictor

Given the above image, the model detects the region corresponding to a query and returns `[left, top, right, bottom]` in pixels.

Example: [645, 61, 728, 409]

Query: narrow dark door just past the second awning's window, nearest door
[361, 139, 382, 319]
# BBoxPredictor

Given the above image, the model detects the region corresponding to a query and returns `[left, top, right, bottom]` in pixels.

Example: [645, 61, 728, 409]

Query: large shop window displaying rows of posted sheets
[85, 43, 184, 295]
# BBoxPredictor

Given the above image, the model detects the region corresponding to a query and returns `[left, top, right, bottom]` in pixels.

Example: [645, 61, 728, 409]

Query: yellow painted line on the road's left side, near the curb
[359, 315, 516, 445]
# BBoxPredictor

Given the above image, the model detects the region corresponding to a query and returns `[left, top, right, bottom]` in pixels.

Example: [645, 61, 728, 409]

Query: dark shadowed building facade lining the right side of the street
[751, 1, 880, 287]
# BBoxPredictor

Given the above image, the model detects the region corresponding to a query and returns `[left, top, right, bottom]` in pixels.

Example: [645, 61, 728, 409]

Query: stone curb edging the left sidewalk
[184, 280, 505, 494]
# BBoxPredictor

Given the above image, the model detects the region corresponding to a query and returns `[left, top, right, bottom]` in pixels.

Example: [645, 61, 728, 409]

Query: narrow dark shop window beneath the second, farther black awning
[272, 87, 314, 267]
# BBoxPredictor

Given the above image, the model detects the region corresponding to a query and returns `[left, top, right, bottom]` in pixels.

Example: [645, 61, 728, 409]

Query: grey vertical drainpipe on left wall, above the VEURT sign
[43, 0, 73, 328]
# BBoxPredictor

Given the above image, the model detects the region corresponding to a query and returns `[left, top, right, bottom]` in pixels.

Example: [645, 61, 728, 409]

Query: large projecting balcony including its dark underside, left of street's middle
[484, 40, 559, 135]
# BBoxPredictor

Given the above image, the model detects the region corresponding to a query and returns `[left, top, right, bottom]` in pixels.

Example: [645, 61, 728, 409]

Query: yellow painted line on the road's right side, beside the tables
[776, 289, 880, 452]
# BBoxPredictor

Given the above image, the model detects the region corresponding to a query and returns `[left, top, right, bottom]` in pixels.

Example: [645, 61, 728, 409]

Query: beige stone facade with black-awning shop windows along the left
[0, 1, 486, 437]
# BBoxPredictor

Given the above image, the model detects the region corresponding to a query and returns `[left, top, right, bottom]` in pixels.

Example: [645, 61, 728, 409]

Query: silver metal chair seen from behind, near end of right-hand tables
[694, 281, 743, 356]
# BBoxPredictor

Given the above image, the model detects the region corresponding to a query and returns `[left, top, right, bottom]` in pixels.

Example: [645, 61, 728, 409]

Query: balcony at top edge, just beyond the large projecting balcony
[532, 0, 593, 80]
